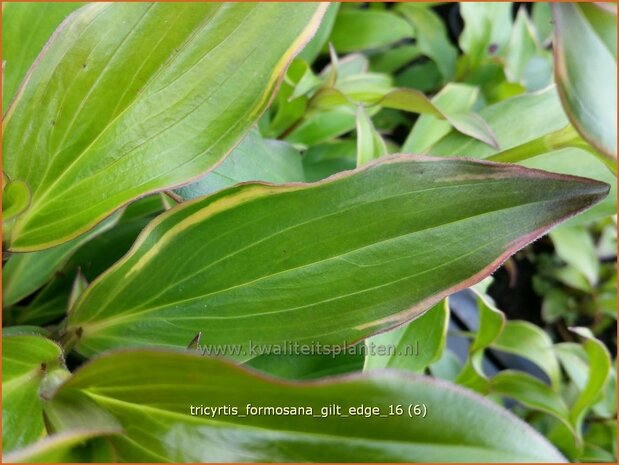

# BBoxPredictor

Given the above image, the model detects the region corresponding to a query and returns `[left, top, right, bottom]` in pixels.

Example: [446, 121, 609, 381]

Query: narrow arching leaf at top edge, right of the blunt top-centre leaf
[396, 3, 458, 81]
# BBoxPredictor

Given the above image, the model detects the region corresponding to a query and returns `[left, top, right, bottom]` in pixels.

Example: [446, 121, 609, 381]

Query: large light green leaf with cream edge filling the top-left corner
[3, 3, 326, 251]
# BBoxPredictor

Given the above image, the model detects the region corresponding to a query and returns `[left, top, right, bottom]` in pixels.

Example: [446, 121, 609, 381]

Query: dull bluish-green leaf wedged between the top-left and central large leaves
[174, 131, 305, 200]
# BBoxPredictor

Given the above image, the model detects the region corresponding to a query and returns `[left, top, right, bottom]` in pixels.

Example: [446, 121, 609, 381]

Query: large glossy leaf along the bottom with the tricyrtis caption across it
[46, 350, 564, 462]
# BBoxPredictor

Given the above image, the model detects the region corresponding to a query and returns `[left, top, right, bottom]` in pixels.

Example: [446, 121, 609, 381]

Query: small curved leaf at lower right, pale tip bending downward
[492, 321, 561, 389]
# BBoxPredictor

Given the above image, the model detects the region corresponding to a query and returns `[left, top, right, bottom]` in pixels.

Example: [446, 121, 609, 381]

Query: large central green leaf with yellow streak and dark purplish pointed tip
[68, 155, 608, 358]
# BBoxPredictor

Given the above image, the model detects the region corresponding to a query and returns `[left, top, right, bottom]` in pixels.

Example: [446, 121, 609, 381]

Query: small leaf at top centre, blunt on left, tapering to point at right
[329, 10, 413, 53]
